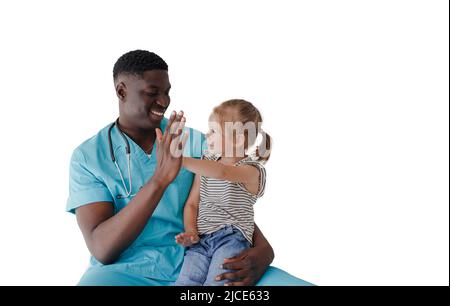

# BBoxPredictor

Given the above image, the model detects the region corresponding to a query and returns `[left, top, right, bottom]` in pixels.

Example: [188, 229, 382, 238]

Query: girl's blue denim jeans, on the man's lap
[175, 225, 251, 286]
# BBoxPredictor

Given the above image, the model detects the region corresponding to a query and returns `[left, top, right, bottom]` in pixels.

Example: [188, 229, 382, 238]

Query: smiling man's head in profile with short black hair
[113, 50, 171, 130]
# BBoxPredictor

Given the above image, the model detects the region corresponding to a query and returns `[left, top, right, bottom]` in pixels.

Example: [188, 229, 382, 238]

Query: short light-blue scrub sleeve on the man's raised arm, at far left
[66, 149, 114, 213]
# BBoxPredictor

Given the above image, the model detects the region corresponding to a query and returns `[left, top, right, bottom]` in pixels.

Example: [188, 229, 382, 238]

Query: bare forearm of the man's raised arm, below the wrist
[90, 178, 168, 264]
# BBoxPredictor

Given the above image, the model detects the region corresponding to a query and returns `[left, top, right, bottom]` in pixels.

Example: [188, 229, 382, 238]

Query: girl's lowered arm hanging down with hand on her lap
[175, 175, 200, 246]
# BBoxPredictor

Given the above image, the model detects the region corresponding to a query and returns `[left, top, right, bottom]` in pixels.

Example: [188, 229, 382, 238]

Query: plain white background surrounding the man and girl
[0, 0, 449, 285]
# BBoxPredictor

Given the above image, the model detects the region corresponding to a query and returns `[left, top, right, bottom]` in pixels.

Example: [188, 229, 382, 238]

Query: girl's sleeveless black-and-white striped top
[197, 152, 266, 244]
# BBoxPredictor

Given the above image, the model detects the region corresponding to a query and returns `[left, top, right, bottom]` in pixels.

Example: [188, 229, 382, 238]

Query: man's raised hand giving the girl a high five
[154, 111, 189, 185]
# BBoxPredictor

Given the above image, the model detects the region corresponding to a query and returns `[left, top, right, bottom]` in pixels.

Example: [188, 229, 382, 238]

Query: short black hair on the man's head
[113, 50, 169, 81]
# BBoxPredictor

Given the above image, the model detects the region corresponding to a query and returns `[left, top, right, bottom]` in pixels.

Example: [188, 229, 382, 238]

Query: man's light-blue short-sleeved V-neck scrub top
[66, 118, 206, 281]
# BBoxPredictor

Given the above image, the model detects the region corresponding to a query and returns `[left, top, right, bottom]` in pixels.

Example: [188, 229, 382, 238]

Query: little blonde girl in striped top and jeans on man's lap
[175, 100, 271, 286]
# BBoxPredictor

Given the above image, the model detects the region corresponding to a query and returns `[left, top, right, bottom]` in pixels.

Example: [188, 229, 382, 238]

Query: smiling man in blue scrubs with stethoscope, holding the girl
[67, 50, 308, 285]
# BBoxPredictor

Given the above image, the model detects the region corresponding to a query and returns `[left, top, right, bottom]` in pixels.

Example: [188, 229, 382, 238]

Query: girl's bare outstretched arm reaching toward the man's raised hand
[183, 157, 259, 186]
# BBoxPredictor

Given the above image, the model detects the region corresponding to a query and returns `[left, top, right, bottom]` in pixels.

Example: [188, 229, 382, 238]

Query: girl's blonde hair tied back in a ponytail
[213, 99, 272, 162]
